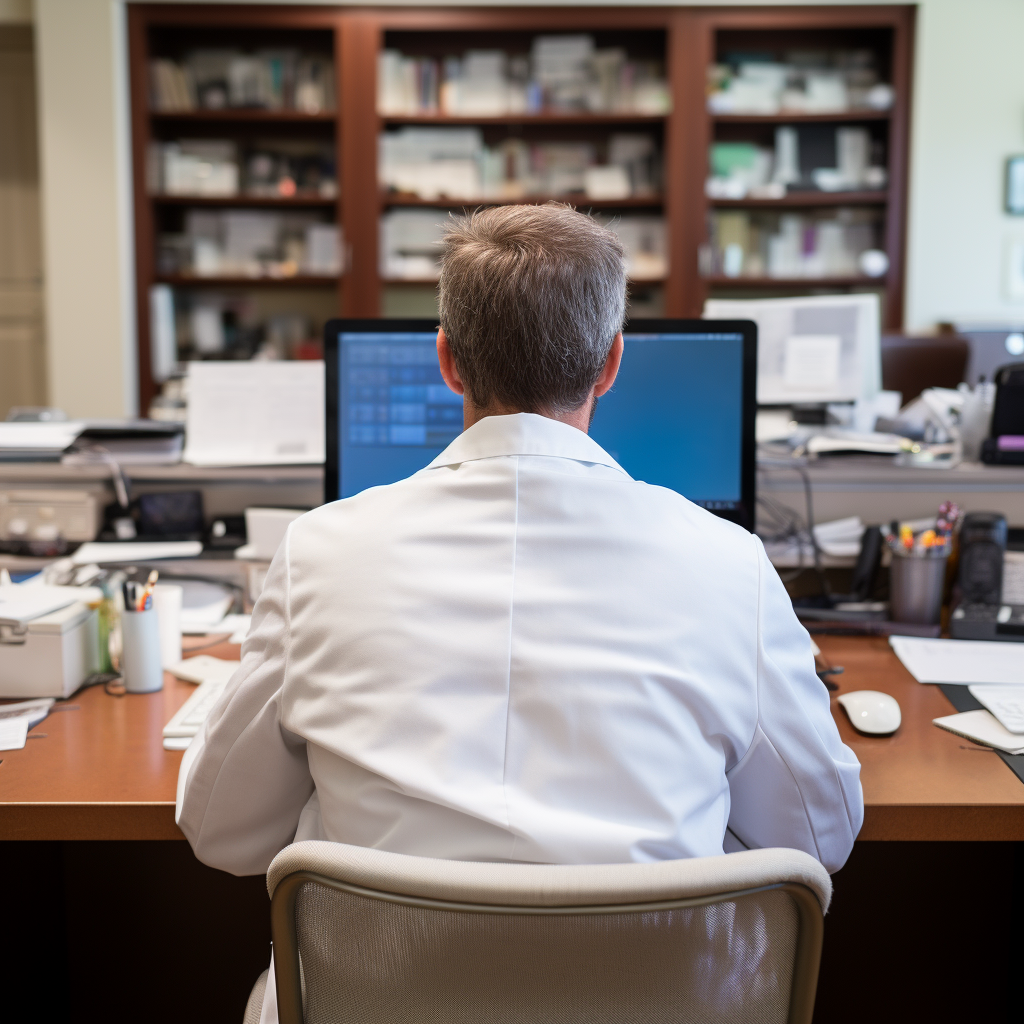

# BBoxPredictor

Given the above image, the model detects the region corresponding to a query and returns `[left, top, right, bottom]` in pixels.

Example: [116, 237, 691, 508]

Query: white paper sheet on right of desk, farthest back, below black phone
[889, 637, 1024, 686]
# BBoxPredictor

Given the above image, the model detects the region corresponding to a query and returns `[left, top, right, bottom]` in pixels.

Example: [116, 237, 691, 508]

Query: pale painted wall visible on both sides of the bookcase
[25, 0, 1024, 416]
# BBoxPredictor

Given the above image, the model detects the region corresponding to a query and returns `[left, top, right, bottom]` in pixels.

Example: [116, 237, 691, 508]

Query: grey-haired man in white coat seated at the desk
[177, 205, 863, 888]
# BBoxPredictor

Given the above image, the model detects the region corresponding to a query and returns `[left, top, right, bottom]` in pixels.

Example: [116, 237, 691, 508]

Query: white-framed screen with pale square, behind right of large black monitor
[705, 293, 882, 406]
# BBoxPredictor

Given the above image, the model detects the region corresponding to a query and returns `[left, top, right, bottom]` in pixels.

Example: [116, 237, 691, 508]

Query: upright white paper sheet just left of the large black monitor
[185, 360, 325, 466]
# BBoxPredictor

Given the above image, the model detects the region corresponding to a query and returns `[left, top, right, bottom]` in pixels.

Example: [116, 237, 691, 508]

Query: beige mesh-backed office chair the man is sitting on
[246, 842, 831, 1024]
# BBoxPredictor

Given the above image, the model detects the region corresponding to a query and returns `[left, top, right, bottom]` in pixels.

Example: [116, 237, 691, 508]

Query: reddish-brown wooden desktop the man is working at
[0, 637, 1024, 840]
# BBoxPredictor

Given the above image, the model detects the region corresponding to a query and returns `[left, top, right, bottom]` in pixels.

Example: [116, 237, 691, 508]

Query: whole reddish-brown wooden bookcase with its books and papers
[123, 3, 913, 413]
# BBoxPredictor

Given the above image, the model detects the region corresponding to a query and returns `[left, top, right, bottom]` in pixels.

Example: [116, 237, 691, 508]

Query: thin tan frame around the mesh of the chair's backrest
[270, 870, 824, 1024]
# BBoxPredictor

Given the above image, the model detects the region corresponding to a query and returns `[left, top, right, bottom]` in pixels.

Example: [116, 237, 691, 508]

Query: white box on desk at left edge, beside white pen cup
[0, 603, 99, 698]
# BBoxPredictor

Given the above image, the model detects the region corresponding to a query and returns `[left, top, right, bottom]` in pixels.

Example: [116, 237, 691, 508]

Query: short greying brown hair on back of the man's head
[440, 204, 626, 413]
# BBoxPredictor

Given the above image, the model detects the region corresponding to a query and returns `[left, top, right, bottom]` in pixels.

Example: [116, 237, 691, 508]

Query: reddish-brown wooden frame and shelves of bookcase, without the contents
[128, 3, 914, 413]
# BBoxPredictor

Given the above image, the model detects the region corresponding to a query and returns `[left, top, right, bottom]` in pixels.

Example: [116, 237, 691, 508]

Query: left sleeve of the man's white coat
[175, 536, 313, 874]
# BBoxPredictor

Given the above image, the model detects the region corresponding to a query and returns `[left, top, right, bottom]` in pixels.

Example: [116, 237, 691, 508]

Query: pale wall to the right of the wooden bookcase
[906, 0, 1024, 328]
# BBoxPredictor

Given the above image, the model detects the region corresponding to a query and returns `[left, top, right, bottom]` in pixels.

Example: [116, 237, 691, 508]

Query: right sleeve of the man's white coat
[728, 538, 864, 871]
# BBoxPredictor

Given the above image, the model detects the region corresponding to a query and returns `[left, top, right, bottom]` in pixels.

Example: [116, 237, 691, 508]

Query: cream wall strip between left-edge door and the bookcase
[35, 0, 136, 417]
